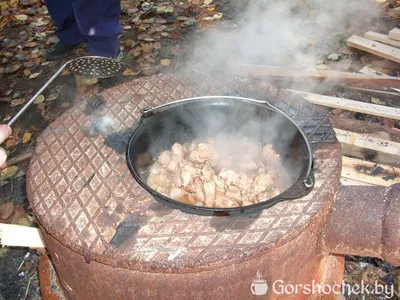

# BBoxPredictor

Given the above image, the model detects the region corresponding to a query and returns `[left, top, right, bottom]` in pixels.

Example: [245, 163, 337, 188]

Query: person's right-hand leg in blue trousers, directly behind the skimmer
[72, 0, 121, 57]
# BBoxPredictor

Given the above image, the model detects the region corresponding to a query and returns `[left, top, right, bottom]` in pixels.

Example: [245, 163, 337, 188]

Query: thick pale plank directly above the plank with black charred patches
[334, 128, 400, 164]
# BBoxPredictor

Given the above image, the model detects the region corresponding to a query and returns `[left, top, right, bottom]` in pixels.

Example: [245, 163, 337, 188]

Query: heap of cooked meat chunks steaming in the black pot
[143, 137, 285, 208]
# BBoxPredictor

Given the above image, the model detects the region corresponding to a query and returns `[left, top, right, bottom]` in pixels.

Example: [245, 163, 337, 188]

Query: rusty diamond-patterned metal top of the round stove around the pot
[27, 74, 340, 272]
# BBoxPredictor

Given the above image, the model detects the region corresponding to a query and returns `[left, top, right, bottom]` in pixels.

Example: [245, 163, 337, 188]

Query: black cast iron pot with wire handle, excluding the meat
[126, 96, 314, 216]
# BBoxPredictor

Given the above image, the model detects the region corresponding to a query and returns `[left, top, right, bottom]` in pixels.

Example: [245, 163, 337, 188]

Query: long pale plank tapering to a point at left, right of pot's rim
[287, 89, 400, 120]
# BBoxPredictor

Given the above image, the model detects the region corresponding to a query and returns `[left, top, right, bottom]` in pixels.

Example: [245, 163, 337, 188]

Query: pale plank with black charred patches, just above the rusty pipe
[342, 156, 400, 186]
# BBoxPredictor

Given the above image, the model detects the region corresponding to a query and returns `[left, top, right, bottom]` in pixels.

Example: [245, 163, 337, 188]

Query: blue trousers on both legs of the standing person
[46, 0, 121, 57]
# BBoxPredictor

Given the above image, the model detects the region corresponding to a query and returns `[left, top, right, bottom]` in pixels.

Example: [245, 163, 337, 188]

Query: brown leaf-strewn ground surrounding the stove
[0, 0, 400, 299]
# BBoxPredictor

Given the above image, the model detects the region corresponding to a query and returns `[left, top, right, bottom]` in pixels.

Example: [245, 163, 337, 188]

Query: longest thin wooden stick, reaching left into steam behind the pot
[229, 64, 400, 88]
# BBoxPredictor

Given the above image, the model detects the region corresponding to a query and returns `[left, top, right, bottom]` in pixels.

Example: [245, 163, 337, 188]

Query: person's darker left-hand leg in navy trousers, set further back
[45, 0, 84, 45]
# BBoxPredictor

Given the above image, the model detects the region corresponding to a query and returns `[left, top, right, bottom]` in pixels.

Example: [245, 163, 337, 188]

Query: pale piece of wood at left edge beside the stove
[0, 223, 46, 248]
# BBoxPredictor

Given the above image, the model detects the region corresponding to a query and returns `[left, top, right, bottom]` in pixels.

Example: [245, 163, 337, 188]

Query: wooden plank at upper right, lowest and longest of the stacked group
[347, 35, 400, 63]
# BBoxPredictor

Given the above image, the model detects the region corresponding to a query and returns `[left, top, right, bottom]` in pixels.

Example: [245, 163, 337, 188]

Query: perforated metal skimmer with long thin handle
[7, 56, 125, 126]
